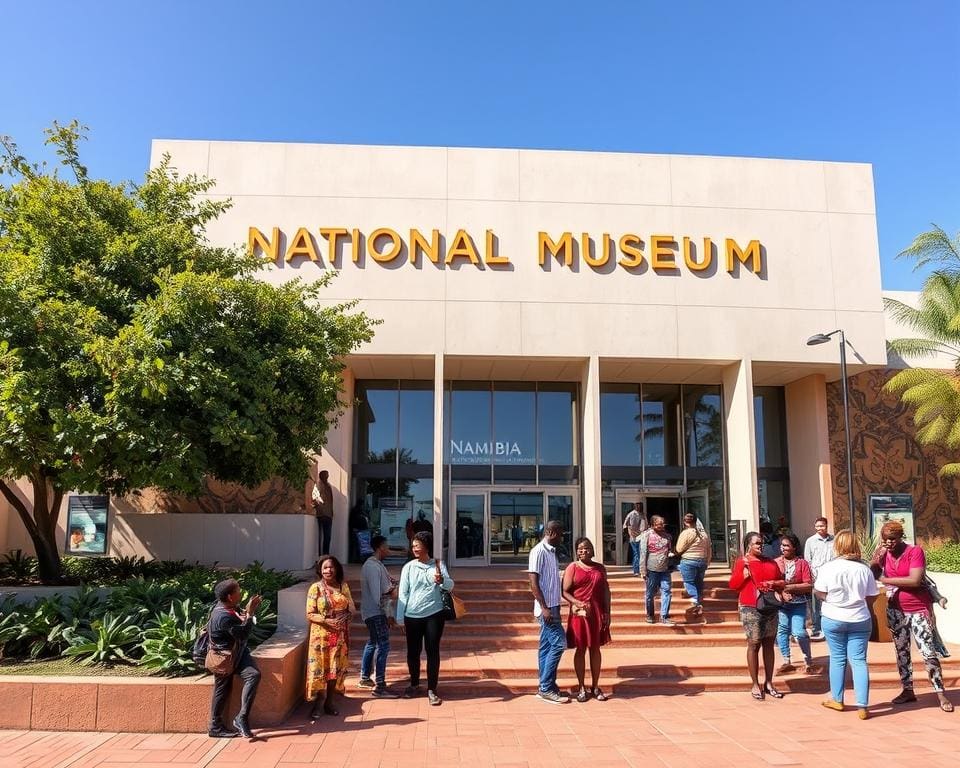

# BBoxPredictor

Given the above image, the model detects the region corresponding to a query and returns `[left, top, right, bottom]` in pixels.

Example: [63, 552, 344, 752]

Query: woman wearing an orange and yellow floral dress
[306, 555, 356, 720]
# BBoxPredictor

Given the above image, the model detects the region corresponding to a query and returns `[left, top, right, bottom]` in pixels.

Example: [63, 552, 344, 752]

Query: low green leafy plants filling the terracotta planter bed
[0, 558, 297, 675]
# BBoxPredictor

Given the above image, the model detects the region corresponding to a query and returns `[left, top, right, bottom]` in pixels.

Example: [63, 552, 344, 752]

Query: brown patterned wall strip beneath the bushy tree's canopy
[118, 478, 304, 515]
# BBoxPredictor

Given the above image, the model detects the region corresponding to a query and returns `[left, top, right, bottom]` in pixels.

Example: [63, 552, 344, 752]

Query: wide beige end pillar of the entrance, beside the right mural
[784, 374, 834, 537]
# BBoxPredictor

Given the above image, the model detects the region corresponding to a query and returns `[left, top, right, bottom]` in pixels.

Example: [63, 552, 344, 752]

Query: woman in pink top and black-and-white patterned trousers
[870, 521, 953, 712]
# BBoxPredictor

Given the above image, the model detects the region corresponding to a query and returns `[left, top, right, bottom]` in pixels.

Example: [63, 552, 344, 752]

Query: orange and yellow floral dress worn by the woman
[306, 581, 355, 701]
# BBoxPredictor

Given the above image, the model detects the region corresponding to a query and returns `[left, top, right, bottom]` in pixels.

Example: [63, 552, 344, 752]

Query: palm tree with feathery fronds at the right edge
[884, 226, 960, 477]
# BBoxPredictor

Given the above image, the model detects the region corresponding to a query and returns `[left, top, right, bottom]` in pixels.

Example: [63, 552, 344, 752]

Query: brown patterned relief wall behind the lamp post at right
[827, 369, 960, 543]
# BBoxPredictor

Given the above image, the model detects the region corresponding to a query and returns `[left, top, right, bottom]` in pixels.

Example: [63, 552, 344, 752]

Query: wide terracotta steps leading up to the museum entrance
[348, 567, 960, 696]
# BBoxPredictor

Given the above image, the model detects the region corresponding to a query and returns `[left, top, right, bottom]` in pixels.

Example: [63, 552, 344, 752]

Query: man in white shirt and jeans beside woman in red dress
[527, 520, 570, 704]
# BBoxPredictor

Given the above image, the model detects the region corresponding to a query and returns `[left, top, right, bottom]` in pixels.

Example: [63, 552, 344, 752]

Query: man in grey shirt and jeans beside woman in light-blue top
[357, 535, 400, 699]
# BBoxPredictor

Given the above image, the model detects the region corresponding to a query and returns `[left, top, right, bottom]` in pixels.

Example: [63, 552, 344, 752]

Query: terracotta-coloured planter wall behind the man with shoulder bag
[0, 627, 307, 733]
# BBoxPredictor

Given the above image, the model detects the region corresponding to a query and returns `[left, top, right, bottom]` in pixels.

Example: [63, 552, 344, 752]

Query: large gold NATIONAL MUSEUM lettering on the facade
[247, 227, 766, 275]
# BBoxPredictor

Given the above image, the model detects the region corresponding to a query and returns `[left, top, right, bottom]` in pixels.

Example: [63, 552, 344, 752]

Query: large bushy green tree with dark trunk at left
[0, 122, 375, 581]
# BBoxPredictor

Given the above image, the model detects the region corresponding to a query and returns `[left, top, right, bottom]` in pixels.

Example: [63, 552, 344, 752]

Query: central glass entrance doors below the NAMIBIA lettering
[449, 486, 580, 565]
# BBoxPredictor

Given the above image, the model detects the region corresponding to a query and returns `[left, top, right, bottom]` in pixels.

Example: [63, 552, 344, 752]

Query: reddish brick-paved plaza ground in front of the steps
[0, 690, 960, 768]
